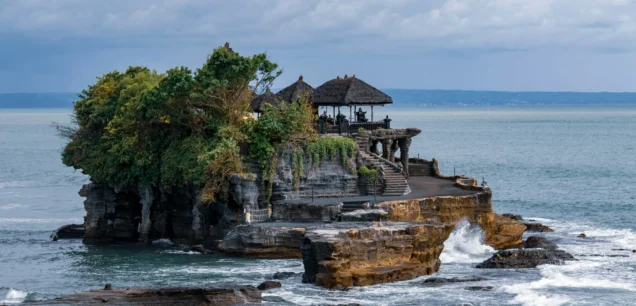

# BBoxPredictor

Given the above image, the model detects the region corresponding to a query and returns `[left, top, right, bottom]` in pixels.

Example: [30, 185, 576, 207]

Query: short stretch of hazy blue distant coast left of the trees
[0, 92, 77, 108]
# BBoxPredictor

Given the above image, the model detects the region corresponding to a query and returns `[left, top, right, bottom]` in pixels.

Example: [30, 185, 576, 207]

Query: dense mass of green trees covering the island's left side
[61, 43, 282, 200]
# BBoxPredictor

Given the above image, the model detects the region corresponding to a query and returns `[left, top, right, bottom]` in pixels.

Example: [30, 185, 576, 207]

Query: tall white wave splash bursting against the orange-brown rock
[440, 219, 495, 263]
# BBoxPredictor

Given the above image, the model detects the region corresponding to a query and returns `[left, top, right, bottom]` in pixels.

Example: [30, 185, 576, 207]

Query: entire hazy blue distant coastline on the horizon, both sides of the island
[0, 89, 636, 108]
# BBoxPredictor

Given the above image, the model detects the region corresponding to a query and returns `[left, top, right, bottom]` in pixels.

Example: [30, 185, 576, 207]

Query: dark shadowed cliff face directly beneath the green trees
[80, 179, 253, 247]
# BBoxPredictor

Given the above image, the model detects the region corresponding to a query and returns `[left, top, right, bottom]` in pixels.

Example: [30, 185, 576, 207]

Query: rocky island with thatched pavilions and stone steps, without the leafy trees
[74, 72, 526, 288]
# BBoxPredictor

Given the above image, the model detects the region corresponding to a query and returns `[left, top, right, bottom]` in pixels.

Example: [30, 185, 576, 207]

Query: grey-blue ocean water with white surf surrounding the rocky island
[0, 106, 636, 305]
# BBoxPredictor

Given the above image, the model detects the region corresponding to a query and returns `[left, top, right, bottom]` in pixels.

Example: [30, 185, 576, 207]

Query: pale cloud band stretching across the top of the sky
[0, 0, 636, 51]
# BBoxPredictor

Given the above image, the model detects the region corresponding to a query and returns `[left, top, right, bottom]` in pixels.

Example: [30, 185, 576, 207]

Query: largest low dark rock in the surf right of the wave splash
[477, 249, 576, 269]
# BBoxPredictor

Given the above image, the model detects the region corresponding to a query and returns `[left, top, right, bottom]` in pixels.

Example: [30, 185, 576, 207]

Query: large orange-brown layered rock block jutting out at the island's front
[302, 222, 453, 288]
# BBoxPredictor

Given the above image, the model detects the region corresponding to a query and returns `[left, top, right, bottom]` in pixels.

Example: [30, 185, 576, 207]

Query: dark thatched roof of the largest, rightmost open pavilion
[313, 75, 393, 106]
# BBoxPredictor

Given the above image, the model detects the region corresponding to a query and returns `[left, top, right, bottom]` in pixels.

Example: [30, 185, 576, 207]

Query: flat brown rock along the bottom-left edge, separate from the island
[29, 286, 261, 306]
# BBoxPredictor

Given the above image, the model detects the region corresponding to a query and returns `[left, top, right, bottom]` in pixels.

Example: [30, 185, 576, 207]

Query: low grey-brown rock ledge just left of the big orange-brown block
[219, 223, 310, 258]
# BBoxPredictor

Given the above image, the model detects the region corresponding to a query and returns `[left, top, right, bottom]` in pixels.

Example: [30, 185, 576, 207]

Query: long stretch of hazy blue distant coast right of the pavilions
[383, 89, 636, 107]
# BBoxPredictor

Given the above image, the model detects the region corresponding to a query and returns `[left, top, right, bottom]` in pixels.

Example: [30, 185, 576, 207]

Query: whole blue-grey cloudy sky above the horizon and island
[0, 0, 636, 93]
